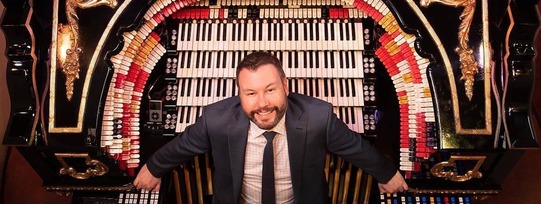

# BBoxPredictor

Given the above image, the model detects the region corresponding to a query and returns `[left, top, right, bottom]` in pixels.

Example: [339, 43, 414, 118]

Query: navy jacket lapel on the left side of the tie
[227, 108, 250, 203]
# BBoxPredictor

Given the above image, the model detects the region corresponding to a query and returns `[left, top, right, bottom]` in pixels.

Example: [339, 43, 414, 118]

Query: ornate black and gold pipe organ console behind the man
[1, 0, 539, 203]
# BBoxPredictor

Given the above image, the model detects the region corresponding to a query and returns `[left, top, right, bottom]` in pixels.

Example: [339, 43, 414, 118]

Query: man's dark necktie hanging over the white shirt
[261, 131, 276, 204]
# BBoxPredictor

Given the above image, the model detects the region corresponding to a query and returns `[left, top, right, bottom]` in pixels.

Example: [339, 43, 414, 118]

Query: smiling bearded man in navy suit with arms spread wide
[134, 52, 408, 204]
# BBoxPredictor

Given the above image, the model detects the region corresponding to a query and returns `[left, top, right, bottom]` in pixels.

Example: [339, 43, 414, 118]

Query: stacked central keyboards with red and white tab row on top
[166, 2, 375, 136]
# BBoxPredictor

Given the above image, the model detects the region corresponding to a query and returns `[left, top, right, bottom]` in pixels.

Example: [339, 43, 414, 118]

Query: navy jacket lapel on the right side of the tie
[286, 100, 306, 201]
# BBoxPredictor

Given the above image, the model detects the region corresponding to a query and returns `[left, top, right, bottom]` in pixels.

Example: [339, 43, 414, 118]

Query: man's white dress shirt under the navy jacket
[241, 116, 293, 204]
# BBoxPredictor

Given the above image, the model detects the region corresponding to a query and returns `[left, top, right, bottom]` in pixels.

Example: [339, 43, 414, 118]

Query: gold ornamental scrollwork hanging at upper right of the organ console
[419, 0, 479, 101]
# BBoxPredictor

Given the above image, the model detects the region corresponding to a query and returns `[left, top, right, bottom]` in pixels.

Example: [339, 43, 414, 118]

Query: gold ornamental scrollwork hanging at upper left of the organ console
[57, 0, 117, 101]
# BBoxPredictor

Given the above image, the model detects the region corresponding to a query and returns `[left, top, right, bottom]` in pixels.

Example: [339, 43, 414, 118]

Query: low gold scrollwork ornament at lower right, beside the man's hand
[430, 156, 486, 182]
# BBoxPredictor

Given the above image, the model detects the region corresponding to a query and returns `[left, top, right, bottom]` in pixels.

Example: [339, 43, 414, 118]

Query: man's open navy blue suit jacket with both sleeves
[147, 93, 396, 204]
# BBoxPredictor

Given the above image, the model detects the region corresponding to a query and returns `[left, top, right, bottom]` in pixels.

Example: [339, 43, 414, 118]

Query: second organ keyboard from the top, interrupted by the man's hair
[175, 50, 364, 78]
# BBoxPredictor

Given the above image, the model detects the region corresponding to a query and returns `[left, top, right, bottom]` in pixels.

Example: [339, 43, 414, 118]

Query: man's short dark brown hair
[237, 51, 286, 83]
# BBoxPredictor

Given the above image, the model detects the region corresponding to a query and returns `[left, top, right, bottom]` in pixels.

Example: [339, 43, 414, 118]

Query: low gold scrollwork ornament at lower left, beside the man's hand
[55, 153, 109, 179]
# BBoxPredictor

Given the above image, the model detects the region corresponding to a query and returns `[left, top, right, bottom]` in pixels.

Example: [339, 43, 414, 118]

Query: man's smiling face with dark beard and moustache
[238, 64, 289, 130]
